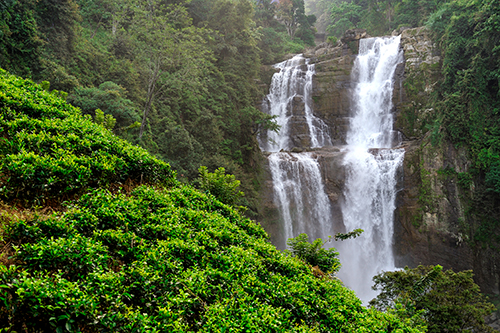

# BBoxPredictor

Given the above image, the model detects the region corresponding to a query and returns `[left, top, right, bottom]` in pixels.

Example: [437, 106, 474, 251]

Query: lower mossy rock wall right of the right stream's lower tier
[394, 137, 474, 271]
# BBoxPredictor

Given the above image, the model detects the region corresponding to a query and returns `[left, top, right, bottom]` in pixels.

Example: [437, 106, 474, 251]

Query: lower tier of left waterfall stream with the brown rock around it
[261, 147, 345, 249]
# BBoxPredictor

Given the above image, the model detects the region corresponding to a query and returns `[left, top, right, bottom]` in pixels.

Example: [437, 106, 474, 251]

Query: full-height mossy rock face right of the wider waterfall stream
[393, 28, 500, 294]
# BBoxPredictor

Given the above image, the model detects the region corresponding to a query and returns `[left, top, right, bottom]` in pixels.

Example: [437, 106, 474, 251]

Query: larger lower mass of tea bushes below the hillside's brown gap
[0, 186, 420, 332]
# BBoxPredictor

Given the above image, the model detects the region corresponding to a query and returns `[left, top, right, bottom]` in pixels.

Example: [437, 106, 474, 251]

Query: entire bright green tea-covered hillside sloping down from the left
[0, 71, 423, 332]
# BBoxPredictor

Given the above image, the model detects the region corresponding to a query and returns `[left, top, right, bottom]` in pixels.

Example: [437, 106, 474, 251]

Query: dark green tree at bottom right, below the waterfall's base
[370, 266, 495, 333]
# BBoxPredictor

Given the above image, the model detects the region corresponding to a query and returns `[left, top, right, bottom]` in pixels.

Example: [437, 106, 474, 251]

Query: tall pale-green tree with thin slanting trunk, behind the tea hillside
[131, 0, 210, 139]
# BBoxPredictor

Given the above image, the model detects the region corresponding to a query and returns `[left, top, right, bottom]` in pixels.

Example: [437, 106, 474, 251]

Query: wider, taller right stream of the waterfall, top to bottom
[337, 37, 404, 302]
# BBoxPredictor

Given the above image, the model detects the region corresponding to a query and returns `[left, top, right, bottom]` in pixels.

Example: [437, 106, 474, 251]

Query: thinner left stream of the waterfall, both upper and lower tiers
[260, 55, 331, 246]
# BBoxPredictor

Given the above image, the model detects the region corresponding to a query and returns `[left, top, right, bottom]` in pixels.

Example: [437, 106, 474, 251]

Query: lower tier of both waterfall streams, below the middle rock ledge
[262, 147, 404, 302]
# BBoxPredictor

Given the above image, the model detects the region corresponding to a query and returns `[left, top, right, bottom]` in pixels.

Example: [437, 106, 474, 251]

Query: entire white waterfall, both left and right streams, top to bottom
[259, 37, 404, 303]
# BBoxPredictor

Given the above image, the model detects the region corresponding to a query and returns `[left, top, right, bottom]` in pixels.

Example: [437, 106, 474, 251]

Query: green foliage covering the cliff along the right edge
[429, 0, 500, 248]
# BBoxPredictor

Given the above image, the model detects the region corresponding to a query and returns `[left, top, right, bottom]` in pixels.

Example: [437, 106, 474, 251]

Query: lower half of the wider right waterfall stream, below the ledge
[335, 148, 405, 302]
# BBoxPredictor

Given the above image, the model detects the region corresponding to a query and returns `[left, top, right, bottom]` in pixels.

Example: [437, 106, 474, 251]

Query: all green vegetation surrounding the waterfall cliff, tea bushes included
[0, 0, 500, 332]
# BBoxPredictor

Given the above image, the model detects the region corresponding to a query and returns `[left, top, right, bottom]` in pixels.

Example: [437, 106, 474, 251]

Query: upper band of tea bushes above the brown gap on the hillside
[0, 71, 175, 203]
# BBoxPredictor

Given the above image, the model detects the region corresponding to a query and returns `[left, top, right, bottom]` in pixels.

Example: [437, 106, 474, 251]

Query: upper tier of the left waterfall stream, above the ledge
[259, 55, 332, 152]
